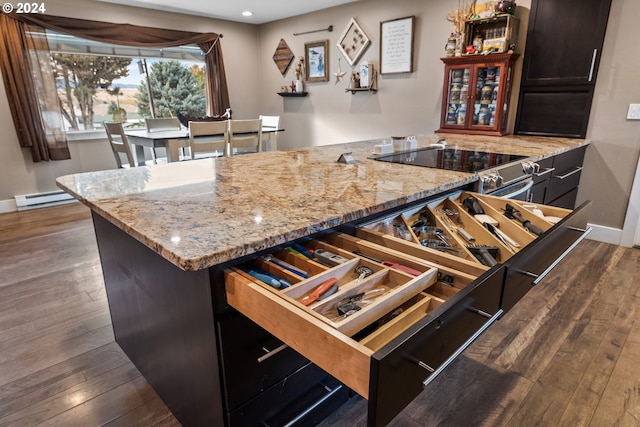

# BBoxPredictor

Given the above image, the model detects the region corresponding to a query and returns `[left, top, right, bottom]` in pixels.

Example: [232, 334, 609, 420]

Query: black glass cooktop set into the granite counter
[371, 147, 526, 172]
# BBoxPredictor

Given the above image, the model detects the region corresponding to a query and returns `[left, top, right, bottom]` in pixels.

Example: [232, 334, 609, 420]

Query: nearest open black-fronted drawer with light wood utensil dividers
[225, 233, 504, 425]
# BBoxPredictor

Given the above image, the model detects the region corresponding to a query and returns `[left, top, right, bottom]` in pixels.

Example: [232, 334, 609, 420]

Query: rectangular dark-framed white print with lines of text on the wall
[380, 16, 415, 74]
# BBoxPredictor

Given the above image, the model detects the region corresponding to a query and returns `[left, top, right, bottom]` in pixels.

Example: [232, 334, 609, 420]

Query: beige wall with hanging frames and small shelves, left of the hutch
[259, 0, 519, 148]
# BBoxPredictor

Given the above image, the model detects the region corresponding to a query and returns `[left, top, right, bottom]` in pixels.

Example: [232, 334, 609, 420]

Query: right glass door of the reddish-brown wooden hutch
[471, 64, 503, 128]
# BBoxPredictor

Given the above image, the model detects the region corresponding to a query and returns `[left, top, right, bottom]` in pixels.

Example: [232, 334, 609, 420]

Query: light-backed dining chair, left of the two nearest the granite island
[189, 120, 229, 159]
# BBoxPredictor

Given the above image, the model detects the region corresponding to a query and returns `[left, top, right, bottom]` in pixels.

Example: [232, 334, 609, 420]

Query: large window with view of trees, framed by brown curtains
[46, 30, 207, 132]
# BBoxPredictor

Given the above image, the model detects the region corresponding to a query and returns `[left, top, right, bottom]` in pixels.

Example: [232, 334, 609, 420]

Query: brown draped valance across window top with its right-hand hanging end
[1, 13, 231, 161]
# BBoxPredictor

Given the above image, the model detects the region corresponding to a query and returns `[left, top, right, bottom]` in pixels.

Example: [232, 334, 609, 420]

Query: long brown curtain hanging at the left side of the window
[0, 13, 71, 162]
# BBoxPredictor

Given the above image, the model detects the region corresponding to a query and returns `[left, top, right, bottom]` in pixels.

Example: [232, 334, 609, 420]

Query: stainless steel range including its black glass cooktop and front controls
[370, 144, 539, 200]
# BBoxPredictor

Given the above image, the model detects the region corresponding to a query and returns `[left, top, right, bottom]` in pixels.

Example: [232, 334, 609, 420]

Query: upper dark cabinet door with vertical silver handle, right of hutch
[522, 0, 611, 86]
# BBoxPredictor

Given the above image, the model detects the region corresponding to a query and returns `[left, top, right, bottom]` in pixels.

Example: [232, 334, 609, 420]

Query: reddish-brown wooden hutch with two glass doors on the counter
[438, 53, 520, 136]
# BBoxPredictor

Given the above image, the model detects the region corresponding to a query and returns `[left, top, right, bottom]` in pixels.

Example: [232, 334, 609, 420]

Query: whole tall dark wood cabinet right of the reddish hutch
[514, 0, 611, 138]
